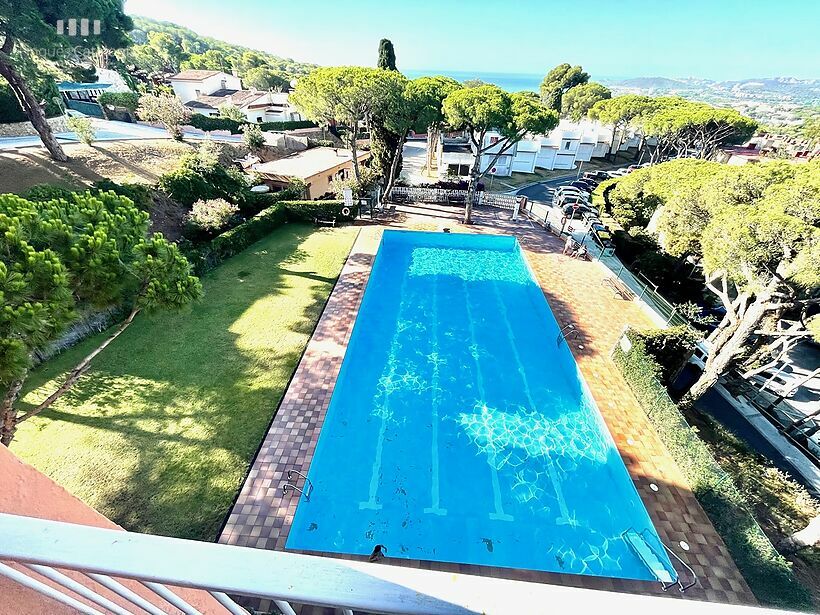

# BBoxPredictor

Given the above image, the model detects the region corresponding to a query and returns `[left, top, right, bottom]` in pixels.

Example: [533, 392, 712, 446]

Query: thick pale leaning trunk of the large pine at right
[681, 296, 769, 406]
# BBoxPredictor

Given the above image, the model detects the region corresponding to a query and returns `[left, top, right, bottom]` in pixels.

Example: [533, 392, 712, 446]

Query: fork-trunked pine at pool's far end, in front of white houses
[442, 85, 558, 224]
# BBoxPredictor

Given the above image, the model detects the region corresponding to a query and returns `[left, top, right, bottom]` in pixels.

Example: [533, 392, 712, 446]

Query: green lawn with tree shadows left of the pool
[11, 224, 357, 540]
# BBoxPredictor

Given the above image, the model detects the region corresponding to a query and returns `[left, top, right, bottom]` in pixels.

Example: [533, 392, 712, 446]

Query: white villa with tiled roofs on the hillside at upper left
[170, 70, 304, 123]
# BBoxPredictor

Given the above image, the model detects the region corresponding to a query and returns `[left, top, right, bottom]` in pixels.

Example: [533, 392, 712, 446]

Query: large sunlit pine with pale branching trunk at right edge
[618, 160, 820, 403]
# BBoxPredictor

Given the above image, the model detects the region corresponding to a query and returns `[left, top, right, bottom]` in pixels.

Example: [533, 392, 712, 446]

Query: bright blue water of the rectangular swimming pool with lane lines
[287, 231, 671, 580]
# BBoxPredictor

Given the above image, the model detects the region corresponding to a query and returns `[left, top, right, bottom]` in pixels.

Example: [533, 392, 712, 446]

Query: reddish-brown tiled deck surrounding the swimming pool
[219, 206, 757, 613]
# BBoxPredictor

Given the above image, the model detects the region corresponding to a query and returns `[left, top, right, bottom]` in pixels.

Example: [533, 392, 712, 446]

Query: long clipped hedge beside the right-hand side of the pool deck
[612, 330, 812, 610]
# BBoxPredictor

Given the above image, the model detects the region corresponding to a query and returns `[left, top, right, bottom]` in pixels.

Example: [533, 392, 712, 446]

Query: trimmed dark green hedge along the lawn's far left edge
[184, 201, 355, 275]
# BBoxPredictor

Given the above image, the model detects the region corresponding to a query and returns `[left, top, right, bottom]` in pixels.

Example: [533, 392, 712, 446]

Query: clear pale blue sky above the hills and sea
[126, 0, 820, 79]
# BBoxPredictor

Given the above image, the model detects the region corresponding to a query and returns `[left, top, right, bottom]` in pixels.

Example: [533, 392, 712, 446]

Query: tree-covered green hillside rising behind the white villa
[117, 16, 316, 81]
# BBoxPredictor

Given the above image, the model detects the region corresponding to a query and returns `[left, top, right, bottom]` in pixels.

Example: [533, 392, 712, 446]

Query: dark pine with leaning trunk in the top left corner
[0, 0, 133, 161]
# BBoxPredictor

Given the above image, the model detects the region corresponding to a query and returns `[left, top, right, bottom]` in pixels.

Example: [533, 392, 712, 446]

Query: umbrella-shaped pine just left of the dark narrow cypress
[291, 66, 407, 182]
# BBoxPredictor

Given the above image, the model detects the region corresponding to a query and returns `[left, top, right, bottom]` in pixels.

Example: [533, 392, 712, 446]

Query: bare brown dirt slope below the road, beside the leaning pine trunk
[0, 139, 247, 193]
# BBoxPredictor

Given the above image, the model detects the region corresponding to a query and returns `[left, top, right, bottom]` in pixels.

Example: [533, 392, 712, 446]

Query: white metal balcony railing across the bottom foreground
[0, 513, 780, 615]
